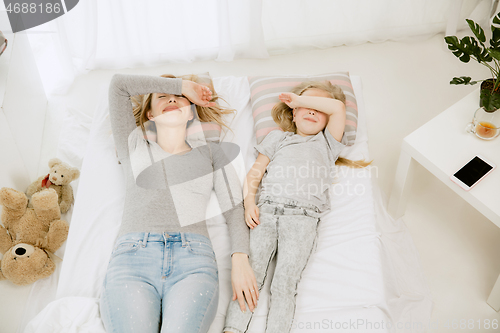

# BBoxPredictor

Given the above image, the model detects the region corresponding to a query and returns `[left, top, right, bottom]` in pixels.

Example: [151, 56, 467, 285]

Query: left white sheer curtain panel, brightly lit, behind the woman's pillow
[29, 0, 268, 94]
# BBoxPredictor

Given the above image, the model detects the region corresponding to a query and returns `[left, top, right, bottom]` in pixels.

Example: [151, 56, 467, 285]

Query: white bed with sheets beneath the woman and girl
[20, 76, 432, 333]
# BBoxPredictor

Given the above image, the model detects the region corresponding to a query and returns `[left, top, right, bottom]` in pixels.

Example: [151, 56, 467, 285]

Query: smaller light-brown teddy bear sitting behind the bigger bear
[26, 158, 80, 214]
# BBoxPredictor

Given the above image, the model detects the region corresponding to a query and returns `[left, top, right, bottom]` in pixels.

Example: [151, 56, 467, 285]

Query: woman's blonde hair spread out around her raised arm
[130, 74, 235, 130]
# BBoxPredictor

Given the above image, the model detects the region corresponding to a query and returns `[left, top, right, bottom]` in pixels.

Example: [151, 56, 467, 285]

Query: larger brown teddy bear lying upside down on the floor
[0, 187, 69, 285]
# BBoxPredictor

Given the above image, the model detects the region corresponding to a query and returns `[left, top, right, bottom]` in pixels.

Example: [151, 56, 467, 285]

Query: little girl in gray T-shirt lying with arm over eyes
[224, 81, 369, 333]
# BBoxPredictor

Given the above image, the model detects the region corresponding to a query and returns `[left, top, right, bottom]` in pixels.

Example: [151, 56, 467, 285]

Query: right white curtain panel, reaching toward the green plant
[262, 0, 493, 55]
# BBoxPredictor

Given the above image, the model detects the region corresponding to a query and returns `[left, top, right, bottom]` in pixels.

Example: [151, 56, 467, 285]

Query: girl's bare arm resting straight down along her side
[243, 153, 270, 229]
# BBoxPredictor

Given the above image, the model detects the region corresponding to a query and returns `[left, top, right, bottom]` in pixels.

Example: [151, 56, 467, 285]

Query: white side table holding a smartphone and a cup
[388, 90, 500, 311]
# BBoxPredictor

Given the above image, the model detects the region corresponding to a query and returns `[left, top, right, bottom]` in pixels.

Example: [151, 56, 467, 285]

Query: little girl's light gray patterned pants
[224, 199, 320, 333]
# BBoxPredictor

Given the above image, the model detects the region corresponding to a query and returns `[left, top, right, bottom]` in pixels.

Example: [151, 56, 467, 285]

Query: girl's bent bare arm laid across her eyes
[279, 93, 346, 142]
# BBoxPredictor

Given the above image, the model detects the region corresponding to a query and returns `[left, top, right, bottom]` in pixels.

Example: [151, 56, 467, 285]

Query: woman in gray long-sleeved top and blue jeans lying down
[100, 74, 256, 333]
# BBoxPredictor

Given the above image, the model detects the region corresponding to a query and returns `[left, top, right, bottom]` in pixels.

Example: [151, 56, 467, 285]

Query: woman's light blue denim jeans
[100, 232, 219, 333]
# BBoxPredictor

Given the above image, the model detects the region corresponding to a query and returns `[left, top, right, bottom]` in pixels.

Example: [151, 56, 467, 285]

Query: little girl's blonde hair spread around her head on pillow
[271, 81, 372, 168]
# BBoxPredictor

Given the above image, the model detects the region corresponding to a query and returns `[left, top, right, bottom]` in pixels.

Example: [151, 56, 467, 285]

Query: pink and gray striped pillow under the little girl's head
[248, 72, 358, 146]
